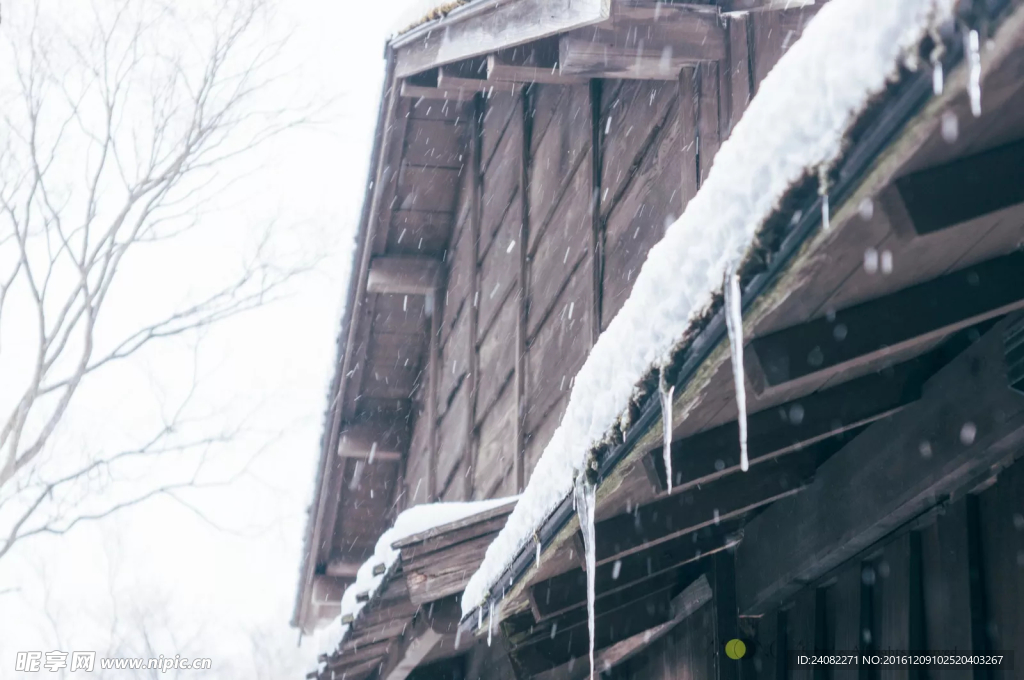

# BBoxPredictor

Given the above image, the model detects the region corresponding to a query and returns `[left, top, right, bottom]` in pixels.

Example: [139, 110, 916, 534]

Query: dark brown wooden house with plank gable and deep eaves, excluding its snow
[293, 0, 1024, 680]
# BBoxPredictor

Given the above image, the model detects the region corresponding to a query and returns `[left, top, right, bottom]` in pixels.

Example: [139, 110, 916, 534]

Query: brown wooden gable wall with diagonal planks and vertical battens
[402, 6, 816, 505]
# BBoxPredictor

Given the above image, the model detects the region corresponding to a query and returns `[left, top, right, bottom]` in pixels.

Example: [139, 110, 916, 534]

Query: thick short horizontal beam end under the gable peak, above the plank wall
[558, 4, 726, 80]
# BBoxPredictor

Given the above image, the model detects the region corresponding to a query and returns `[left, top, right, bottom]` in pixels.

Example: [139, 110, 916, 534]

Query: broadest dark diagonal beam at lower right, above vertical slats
[736, 321, 1024, 613]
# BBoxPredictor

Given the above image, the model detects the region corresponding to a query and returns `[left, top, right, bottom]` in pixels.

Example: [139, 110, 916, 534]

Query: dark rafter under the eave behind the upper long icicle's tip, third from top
[645, 359, 930, 492]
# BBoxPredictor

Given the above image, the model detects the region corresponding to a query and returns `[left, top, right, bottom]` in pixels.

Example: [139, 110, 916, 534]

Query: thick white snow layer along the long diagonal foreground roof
[462, 0, 955, 615]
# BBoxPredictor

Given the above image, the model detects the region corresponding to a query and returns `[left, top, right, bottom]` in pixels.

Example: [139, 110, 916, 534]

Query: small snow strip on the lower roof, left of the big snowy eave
[317, 497, 515, 655]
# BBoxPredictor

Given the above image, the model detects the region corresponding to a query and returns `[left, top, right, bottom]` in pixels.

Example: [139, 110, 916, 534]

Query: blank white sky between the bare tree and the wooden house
[0, 0, 428, 679]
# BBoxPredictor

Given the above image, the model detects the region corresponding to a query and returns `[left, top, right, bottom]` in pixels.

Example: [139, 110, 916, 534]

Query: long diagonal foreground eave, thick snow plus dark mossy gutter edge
[463, 0, 987, 626]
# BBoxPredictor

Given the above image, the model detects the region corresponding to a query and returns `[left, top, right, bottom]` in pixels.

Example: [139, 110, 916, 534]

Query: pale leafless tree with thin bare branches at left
[0, 0, 305, 557]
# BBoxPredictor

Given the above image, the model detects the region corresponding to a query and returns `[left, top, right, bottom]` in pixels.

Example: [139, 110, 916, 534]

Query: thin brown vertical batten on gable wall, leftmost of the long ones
[463, 93, 484, 500]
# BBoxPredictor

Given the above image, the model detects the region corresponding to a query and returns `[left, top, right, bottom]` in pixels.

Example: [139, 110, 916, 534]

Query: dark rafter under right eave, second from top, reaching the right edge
[744, 252, 1024, 391]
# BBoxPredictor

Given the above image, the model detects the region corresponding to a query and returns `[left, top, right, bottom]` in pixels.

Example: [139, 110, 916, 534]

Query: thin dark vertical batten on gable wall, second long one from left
[513, 87, 535, 494]
